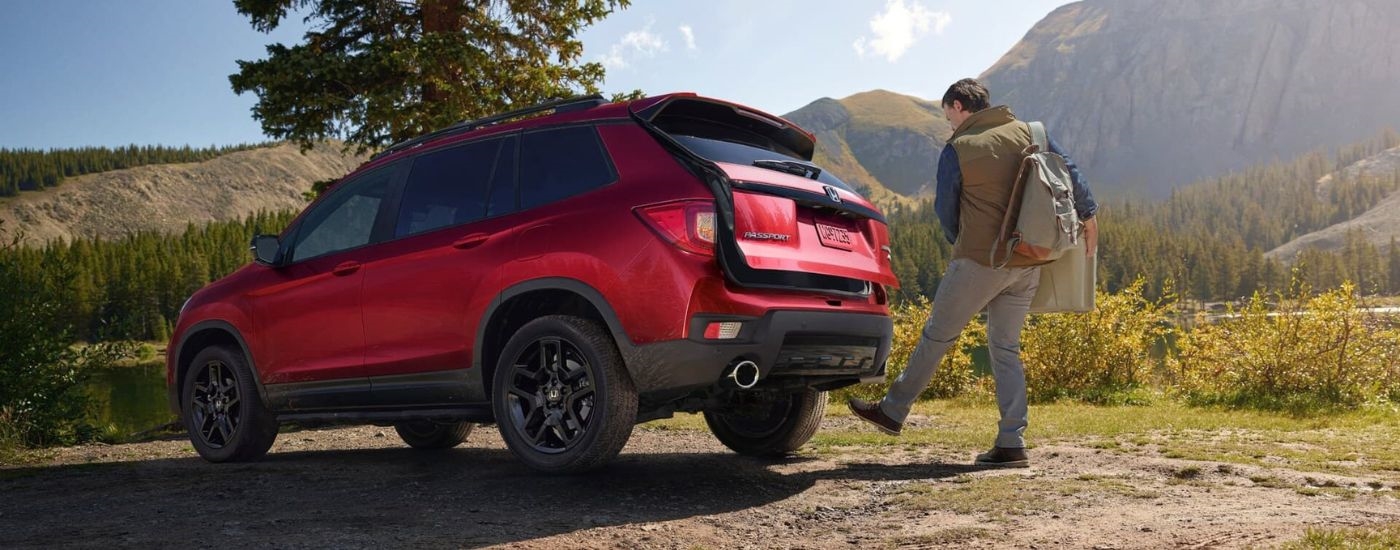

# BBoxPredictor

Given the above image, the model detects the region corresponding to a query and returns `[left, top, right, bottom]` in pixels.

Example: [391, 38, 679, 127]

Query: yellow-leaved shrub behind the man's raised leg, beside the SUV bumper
[833, 297, 987, 400]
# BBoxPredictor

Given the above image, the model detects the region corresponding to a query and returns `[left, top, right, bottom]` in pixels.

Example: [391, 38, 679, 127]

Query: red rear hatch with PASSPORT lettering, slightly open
[634, 95, 899, 295]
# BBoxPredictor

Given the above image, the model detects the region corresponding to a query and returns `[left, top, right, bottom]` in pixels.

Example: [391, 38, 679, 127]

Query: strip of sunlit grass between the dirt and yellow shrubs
[643, 399, 1400, 484]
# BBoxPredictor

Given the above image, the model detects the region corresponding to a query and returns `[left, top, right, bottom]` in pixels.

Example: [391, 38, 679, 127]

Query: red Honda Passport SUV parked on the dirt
[167, 94, 896, 472]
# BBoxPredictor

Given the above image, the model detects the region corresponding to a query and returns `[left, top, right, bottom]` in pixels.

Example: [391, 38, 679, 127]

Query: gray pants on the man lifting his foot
[881, 258, 1040, 448]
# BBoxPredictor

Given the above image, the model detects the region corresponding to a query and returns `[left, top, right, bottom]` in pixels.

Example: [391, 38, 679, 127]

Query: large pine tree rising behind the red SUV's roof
[228, 0, 630, 151]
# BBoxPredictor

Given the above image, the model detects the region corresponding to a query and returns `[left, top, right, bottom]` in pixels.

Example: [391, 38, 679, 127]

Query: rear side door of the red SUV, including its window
[364, 136, 518, 386]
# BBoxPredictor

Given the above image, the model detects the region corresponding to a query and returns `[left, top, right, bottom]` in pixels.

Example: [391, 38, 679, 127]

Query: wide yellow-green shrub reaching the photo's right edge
[1172, 283, 1400, 411]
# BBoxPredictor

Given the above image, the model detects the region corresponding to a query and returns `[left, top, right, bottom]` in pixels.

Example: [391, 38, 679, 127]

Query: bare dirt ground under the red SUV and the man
[0, 417, 1400, 549]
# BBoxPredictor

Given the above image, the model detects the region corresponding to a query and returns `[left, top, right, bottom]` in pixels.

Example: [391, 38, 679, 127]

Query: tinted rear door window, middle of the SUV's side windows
[393, 140, 503, 237]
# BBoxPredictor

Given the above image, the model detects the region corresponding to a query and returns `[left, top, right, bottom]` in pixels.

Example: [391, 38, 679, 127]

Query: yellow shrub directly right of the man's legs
[1021, 278, 1175, 403]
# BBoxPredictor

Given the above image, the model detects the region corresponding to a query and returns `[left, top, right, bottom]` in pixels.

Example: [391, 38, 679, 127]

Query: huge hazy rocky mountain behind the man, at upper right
[981, 0, 1400, 196]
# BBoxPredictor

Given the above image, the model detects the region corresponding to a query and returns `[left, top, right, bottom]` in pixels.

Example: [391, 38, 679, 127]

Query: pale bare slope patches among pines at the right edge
[1268, 147, 1400, 262]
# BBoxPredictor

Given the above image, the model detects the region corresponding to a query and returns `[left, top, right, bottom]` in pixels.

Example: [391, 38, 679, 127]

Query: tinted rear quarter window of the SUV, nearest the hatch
[519, 126, 616, 209]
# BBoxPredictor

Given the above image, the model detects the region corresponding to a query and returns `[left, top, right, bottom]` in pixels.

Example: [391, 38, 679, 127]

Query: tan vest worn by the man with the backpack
[948, 105, 1043, 267]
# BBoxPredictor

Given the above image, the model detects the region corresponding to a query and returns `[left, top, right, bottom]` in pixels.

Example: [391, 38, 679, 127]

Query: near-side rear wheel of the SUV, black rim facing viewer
[491, 315, 637, 473]
